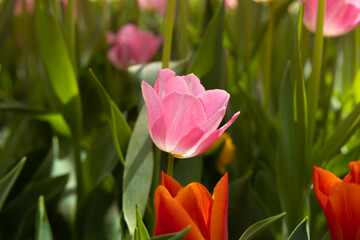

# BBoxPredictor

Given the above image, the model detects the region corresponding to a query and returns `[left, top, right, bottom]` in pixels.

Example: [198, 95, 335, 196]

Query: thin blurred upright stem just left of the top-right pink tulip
[264, 2, 274, 110]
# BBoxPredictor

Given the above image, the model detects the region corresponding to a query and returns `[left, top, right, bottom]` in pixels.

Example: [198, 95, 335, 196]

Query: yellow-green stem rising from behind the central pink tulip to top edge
[162, 0, 176, 68]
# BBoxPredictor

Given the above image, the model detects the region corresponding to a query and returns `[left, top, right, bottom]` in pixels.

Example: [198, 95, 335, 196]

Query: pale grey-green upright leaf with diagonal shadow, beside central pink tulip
[122, 106, 154, 234]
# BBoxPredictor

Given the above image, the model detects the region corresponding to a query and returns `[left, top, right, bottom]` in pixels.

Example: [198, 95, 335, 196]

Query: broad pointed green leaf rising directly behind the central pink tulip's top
[188, 3, 225, 89]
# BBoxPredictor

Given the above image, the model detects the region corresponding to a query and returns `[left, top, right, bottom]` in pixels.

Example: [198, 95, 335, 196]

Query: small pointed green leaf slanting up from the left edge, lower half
[0, 157, 26, 211]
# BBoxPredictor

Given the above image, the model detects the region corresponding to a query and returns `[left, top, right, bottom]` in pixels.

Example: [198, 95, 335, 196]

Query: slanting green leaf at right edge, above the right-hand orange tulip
[312, 103, 360, 166]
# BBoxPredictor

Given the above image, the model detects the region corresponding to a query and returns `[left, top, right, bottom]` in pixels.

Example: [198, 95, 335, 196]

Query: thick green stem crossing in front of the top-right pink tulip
[307, 0, 325, 151]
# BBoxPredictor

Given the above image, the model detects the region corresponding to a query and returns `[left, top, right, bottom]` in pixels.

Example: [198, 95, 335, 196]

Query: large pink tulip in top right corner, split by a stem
[301, 0, 360, 37]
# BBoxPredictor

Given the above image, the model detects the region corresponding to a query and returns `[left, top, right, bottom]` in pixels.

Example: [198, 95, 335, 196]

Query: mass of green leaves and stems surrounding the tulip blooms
[0, 0, 360, 239]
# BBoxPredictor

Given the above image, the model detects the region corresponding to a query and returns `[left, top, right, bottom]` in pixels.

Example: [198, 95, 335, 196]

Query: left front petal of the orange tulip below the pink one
[154, 186, 204, 240]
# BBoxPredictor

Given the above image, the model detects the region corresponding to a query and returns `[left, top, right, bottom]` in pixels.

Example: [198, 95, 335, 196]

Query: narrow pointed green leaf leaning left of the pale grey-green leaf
[89, 69, 131, 164]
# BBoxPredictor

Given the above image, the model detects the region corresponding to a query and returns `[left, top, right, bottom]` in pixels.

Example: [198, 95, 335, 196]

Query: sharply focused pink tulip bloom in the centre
[141, 69, 239, 158]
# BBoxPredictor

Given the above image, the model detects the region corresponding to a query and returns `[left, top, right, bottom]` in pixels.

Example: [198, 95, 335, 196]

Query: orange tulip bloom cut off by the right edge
[313, 161, 360, 240]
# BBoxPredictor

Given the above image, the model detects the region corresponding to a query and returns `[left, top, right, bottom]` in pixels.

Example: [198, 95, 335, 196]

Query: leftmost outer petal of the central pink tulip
[141, 81, 166, 150]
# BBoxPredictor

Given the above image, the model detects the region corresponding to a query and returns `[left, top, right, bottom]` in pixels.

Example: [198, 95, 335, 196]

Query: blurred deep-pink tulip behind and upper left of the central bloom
[106, 24, 162, 69]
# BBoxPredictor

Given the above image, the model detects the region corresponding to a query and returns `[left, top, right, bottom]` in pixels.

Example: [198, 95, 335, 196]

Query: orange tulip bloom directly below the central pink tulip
[154, 173, 229, 240]
